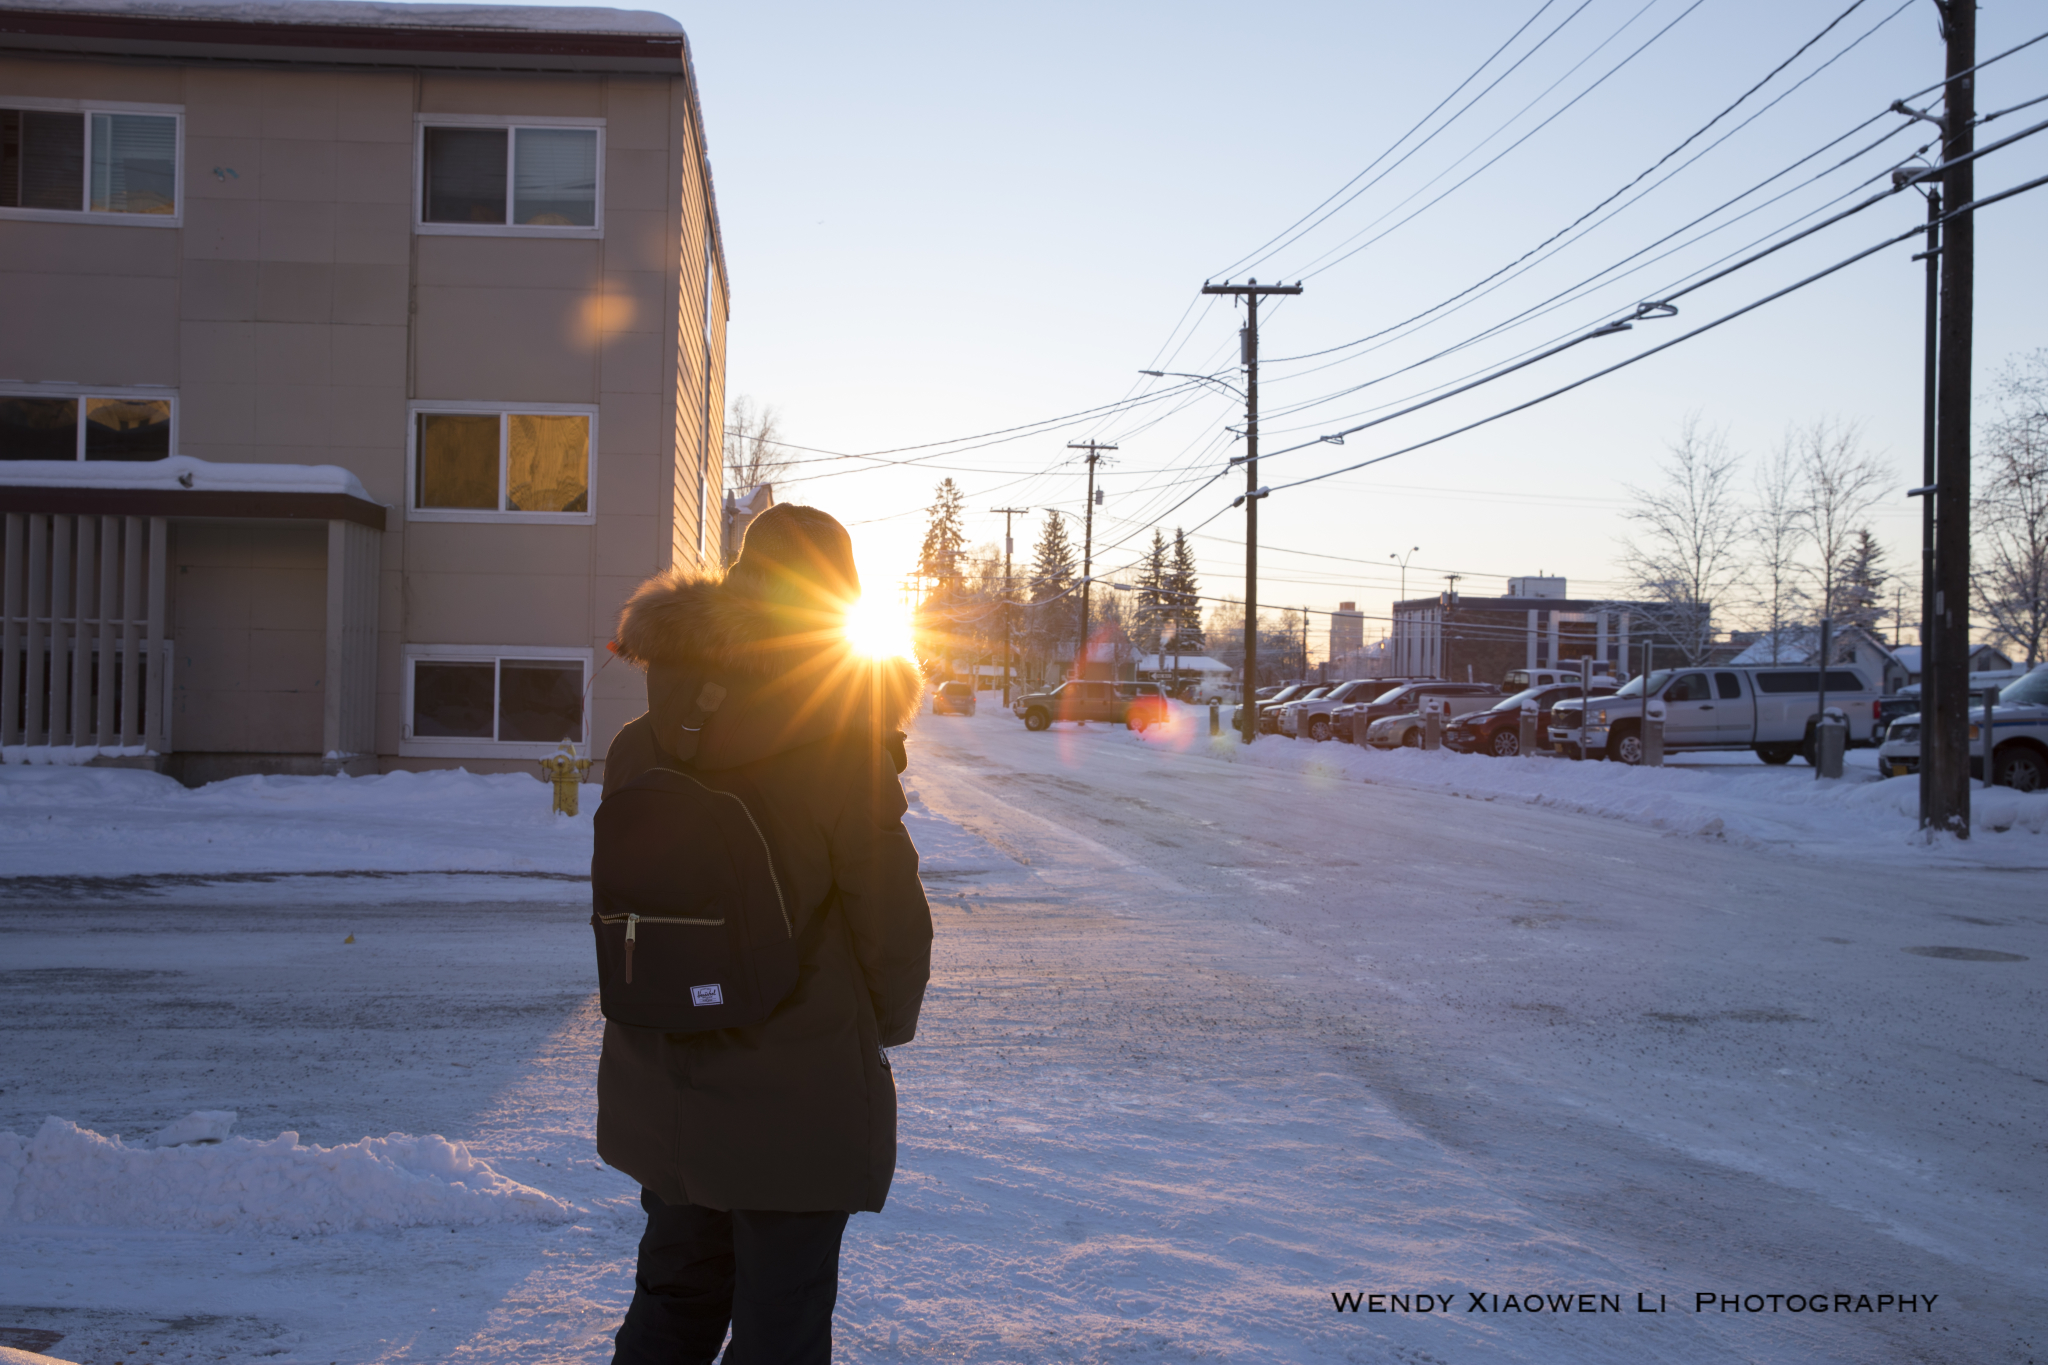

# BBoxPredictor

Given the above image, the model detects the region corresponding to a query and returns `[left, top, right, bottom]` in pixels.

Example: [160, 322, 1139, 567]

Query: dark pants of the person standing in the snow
[612, 1189, 846, 1365]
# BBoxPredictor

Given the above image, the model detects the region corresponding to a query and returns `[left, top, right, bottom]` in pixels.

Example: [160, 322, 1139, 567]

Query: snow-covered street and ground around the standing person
[0, 706, 2048, 1365]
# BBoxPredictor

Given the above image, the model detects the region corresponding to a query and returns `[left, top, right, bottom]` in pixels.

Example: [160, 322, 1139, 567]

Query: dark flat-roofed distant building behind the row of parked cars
[1384, 577, 1677, 684]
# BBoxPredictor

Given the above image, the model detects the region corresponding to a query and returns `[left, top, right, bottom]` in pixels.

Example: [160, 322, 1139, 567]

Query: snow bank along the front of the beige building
[0, 763, 598, 876]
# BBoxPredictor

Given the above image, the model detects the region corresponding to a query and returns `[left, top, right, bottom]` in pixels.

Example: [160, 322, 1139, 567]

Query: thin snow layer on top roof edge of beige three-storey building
[6, 0, 682, 33]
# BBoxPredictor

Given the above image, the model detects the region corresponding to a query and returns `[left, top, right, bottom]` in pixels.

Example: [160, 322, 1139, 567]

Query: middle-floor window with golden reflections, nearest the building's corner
[410, 403, 598, 524]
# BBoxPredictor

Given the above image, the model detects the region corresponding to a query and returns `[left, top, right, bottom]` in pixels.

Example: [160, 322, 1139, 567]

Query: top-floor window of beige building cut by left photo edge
[0, 96, 182, 227]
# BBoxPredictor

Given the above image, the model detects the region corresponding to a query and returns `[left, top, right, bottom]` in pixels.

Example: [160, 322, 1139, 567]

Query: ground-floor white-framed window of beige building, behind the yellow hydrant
[401, 645, 590, 757]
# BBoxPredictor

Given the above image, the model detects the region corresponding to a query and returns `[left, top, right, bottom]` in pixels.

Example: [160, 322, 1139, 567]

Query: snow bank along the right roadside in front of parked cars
[1208, 735, 2048, 847]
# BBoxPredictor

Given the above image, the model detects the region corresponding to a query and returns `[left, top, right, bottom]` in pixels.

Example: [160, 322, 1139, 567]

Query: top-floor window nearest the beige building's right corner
[418, 115, 604, 237]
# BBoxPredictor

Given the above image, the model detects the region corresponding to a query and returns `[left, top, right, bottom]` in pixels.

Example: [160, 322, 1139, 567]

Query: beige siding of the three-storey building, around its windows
[0, 48, 725, 767]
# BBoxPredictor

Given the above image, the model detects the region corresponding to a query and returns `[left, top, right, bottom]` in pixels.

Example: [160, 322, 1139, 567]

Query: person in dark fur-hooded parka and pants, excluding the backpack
[598, 505, 932, 1365]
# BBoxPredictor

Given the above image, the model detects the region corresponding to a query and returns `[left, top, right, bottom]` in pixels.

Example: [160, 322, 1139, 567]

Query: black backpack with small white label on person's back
[590, 767, 797, 1033]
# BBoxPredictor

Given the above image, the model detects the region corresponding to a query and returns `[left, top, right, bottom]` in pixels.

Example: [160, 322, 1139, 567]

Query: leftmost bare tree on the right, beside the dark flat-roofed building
[1622, 413, 1745, 663]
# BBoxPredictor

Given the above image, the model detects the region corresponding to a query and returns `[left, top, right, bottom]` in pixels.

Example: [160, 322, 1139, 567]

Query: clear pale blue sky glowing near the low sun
[520, 0, 2048, 658]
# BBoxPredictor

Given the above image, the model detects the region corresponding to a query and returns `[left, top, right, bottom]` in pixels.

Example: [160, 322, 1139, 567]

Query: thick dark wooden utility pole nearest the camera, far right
[1921, 0, 1991, 839]
